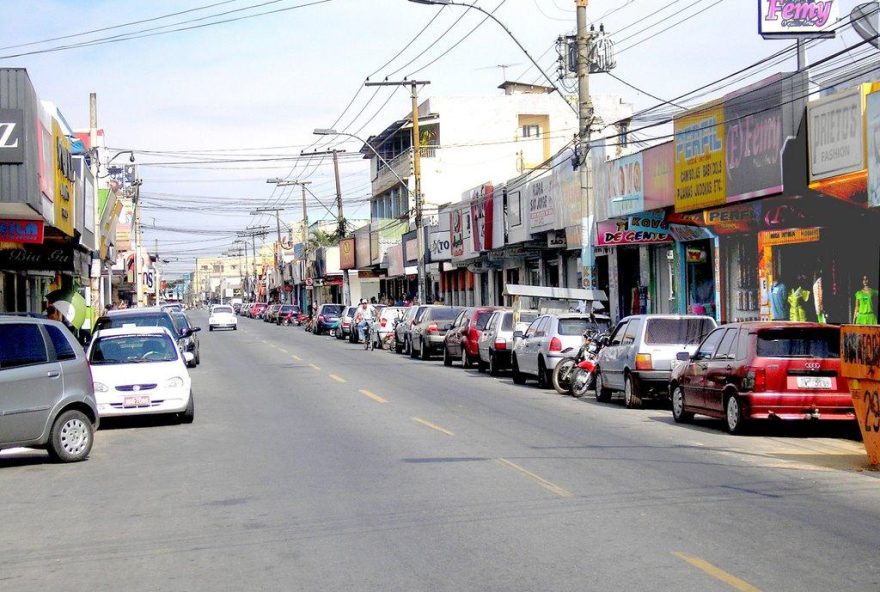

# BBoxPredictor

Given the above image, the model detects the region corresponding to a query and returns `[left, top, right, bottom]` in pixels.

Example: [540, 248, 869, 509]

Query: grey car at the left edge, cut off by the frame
[0, 316, 99, 462]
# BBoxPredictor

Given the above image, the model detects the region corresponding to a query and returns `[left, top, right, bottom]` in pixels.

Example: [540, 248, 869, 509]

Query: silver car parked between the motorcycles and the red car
[596, 315, 717, 407]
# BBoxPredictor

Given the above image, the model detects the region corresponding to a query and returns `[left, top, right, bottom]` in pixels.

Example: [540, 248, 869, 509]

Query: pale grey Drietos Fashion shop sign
[807, 87, 865, 182]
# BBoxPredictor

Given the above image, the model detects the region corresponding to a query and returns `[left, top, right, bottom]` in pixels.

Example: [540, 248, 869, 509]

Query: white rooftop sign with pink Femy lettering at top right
[758, 0, 840, 39]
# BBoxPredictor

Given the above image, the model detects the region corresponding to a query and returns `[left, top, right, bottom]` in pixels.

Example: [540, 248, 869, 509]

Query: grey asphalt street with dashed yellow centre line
[0, 312, 880, 592]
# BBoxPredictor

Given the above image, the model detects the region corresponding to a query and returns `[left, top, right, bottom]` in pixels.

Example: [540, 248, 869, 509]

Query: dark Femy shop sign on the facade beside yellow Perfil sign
[724, 76, 790, 202]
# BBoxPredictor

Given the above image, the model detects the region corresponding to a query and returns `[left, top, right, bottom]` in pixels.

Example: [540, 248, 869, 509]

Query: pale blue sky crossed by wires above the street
[0, 0, 856, 271]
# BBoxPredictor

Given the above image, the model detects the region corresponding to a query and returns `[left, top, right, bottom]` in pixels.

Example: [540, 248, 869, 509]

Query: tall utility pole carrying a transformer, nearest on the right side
[575, 0, 598, 290]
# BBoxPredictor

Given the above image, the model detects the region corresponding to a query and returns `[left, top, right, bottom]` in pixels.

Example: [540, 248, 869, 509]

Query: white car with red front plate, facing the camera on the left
[87, 327, 195, 423]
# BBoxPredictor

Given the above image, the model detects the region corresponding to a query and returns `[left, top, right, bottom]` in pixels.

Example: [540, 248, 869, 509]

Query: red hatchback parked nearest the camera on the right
[670, 322, 856, 434]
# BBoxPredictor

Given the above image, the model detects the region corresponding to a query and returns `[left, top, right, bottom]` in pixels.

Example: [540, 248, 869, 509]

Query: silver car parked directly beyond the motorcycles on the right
[510, 313, 610, 388]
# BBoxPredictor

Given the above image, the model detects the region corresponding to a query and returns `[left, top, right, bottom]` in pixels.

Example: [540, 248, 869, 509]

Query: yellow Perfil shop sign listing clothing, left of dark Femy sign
[675, 106, 726, 212]
